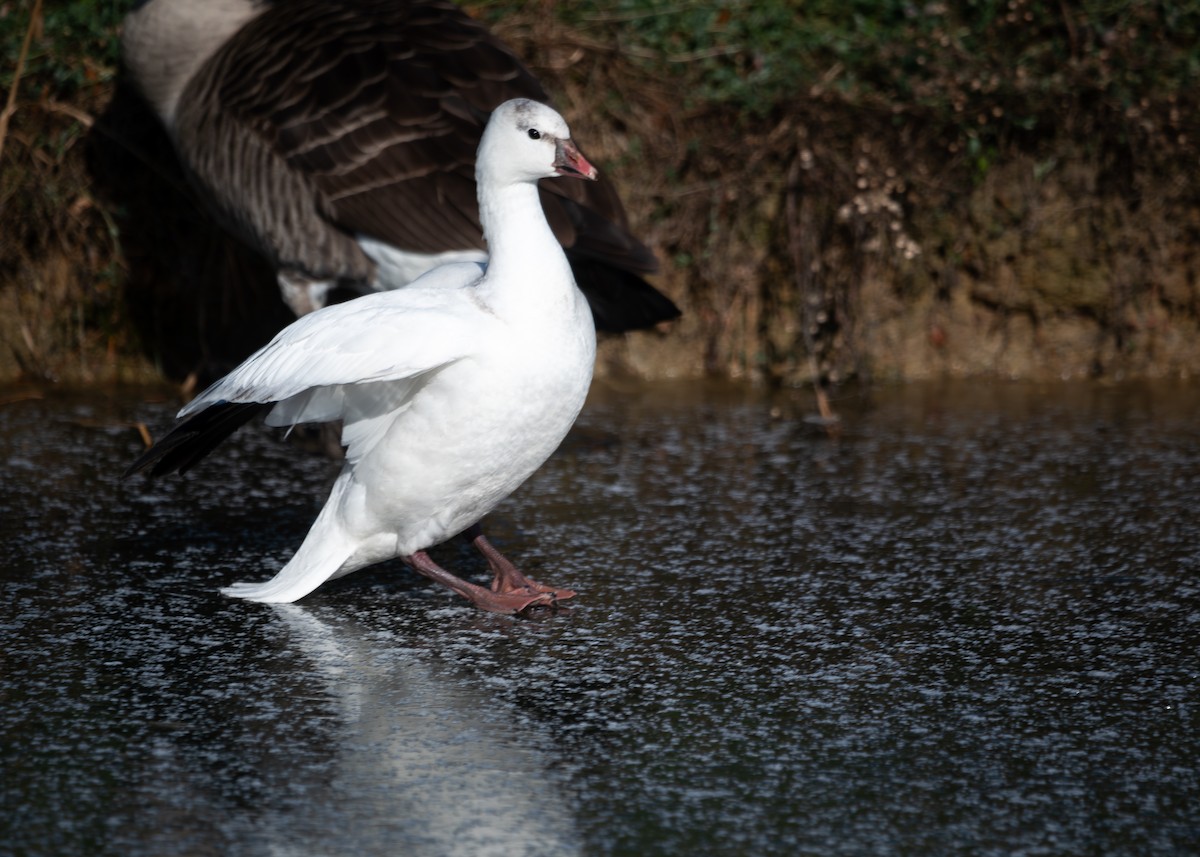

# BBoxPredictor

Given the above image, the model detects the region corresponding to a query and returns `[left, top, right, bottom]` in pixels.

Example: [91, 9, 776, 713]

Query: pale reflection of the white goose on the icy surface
[262, 605, 581, 857]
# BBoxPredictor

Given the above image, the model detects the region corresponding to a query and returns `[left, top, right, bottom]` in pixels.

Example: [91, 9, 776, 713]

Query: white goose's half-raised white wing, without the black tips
[179, 263, 490, 425]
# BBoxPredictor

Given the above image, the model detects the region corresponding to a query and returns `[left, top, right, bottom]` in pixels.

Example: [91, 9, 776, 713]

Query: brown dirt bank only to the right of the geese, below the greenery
[514, 4, 1200, 384]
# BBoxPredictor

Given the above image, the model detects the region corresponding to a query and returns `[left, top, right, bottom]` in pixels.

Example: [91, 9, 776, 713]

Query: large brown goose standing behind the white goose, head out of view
[122, 0, 679, 331]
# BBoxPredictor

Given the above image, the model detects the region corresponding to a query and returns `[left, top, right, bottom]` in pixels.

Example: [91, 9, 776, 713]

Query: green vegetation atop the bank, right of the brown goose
[485, 0, 1200, 140]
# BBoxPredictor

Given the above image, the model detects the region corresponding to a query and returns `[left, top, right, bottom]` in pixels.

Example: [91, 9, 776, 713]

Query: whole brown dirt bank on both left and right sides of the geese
[0, 5, 1200, 384]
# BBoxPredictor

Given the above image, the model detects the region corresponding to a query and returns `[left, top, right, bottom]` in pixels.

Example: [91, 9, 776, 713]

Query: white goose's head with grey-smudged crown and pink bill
[475, 98, 598, 186]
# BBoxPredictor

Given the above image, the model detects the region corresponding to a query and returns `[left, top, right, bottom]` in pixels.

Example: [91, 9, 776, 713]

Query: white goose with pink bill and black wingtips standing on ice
[126, 100, 596, 612]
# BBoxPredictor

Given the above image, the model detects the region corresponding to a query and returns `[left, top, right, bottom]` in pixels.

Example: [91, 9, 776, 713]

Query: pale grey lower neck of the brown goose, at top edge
[121, 0, 268, 130]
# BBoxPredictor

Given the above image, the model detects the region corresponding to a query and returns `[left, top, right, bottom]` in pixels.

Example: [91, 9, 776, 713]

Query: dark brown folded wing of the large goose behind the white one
[232, 0, 546, 253]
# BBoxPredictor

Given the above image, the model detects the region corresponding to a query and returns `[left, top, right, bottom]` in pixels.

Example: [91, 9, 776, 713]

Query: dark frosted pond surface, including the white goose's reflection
[0, 385, 1200, 856]
